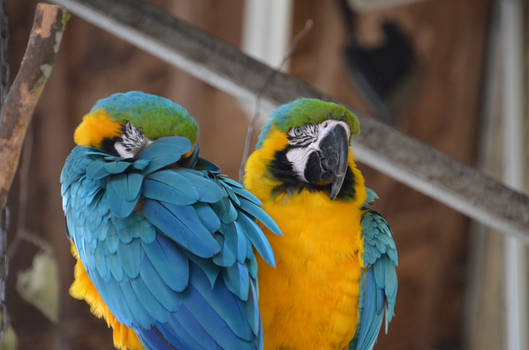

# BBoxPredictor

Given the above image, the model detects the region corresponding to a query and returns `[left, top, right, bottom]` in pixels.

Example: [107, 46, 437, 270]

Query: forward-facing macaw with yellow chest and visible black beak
[244, 99, 397, 350]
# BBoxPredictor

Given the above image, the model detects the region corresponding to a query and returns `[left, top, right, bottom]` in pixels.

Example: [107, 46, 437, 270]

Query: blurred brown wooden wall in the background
[8, 0, 488, 350]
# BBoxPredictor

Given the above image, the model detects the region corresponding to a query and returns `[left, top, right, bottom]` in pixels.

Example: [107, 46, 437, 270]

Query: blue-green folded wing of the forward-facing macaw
[349, 190, 398, 350]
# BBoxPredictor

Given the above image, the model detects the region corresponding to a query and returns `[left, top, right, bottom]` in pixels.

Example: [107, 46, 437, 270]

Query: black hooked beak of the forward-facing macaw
[304, 124, 349, 200]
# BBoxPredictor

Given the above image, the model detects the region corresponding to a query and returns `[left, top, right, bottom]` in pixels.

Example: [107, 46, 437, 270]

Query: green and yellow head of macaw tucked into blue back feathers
[74, 91, 198, 158]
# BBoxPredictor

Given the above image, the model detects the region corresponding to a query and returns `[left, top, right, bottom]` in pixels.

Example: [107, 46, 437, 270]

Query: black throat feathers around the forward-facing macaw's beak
[268, 145, 356, 200]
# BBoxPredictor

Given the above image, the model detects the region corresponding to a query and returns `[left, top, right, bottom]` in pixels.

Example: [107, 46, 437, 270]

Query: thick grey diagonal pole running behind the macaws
[53, 0, 529, 243]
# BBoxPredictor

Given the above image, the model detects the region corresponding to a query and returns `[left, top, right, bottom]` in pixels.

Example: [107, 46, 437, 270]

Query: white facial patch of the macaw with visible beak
[286, 120, 351, 182]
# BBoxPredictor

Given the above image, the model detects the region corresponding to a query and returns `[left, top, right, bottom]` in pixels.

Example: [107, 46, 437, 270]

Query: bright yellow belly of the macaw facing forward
[259, 191, 363, 350]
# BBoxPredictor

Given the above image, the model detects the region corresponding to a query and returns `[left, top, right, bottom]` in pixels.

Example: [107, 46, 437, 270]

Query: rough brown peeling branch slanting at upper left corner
[0, 4, 70, 210]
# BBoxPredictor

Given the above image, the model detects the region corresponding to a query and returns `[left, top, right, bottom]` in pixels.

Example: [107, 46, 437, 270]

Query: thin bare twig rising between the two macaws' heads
[239, 18, 314, 182]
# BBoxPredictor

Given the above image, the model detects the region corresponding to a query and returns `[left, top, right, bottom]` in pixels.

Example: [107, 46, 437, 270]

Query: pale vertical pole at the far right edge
[500, 0, 528, 350]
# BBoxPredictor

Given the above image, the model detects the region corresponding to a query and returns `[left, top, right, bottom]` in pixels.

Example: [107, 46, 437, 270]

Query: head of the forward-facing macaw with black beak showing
[246, 98, 359, 200]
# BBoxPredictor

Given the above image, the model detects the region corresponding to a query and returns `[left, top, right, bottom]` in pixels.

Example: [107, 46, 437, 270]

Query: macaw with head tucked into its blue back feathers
[61, 92, 280, 350]
